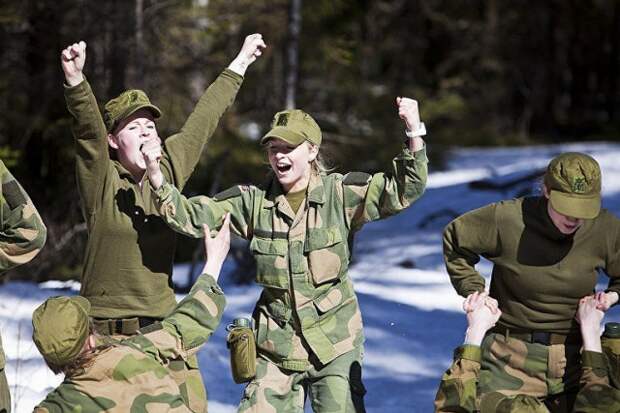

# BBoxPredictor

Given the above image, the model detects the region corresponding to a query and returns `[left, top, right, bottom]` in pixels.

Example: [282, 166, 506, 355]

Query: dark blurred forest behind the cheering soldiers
[0, 0, 620, 281]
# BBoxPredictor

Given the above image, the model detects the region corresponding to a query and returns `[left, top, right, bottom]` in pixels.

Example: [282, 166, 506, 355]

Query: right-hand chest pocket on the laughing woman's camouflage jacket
[304, 227, 349, 285]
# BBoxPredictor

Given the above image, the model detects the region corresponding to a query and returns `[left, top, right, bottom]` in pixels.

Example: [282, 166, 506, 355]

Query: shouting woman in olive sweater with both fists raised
[61, 34, 265, 412]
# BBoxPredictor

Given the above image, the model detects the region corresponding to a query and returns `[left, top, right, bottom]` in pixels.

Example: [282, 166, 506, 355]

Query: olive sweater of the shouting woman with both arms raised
[65, 69, 243, 318]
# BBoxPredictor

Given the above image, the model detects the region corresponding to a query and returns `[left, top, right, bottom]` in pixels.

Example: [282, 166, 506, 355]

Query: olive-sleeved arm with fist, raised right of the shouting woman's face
[161, 33, 266, 189]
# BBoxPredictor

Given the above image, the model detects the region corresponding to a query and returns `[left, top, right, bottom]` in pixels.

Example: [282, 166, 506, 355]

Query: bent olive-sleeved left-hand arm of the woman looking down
[443, 204, 500, 297]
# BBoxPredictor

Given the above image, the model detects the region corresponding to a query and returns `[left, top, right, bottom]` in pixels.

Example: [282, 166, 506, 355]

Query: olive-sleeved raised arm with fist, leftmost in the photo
[60, 41, 110, 219]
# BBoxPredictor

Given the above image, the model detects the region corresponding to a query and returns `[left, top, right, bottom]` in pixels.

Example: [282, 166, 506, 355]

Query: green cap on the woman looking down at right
[545, 152, 601, 219]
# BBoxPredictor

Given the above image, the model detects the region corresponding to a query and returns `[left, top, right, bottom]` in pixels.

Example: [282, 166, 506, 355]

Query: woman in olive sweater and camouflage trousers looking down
[444, 153, 620, 411]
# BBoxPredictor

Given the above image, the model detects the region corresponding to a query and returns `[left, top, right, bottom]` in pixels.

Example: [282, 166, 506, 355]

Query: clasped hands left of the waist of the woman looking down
[463, 292, 502, 346]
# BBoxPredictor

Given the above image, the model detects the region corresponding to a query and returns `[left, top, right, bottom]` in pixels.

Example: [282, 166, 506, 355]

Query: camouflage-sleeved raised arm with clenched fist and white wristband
[342, 97, 428, 230]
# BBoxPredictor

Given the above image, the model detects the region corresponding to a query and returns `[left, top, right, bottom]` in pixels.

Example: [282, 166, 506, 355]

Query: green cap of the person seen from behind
[32, 296, 90, 366]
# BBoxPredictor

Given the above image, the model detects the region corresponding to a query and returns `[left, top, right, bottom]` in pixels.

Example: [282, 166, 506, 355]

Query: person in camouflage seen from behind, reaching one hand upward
[32, 217, 230, 413]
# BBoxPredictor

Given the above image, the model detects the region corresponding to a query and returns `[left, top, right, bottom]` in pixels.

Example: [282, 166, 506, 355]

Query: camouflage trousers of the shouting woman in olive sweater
[101, 328, 208, 413]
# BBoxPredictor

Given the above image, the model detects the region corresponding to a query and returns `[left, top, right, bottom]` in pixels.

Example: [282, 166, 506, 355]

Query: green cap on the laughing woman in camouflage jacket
[260, 109, 323, 146]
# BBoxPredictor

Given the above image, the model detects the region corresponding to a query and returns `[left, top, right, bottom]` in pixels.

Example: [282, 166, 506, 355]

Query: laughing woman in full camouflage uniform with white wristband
[147, 98, 427, 413]
